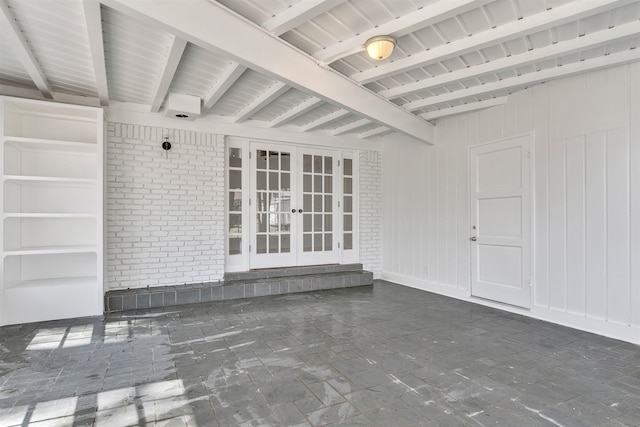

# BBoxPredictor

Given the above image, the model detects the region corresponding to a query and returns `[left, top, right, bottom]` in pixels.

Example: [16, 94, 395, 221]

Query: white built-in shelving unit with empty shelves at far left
[0, 97, 104, 325]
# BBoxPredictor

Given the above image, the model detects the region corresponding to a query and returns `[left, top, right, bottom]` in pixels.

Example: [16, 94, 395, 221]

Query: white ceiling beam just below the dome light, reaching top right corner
[351, 0, 637, 84]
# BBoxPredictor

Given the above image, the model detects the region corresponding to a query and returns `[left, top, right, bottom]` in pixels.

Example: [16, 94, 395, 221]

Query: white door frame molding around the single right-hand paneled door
[466, 130, 537, 312]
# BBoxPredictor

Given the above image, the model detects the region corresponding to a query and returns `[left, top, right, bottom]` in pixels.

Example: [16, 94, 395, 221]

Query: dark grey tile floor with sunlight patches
[0, 281, 640, 427]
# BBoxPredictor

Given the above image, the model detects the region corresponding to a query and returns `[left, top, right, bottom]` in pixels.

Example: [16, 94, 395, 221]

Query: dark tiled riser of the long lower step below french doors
[105, 271, 373, 312]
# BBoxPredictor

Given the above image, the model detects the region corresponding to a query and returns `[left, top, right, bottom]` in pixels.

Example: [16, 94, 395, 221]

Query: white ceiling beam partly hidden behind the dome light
[313, 0, 494, 63]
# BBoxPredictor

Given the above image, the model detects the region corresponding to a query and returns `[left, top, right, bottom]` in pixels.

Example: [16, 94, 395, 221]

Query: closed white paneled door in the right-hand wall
[469, 135, 531, 308]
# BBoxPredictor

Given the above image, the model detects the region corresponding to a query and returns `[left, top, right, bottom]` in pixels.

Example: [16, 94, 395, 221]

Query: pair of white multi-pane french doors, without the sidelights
[250, 143, 340, 268]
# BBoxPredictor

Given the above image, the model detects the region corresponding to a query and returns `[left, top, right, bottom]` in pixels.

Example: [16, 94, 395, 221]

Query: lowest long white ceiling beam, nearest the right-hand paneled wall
[403, 49, 640, 111]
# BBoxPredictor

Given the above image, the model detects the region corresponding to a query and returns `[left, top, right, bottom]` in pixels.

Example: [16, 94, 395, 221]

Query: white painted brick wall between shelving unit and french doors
[105, 123, 224, 289]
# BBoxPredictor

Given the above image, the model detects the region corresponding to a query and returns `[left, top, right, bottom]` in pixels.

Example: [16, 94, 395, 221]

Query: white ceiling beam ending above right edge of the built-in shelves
[83, 0, 109, 106]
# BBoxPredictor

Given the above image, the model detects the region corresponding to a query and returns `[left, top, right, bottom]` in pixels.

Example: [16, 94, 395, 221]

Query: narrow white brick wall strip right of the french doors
[359, 151, 382, 279]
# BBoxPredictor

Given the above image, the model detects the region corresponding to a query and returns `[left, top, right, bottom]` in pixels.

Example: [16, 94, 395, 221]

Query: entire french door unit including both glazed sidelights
[226, 141, 357, 271]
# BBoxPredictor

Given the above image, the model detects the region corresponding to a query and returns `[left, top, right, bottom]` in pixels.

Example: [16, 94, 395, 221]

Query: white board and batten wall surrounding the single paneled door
[382, 63, 640, 343]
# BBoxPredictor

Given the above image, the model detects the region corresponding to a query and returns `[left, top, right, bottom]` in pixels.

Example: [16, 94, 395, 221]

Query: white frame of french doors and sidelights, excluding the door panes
[225, 138, 359, 272]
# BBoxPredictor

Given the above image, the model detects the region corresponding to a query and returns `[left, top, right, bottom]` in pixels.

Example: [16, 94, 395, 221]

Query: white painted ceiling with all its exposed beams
[0, 0, 640, 142]
